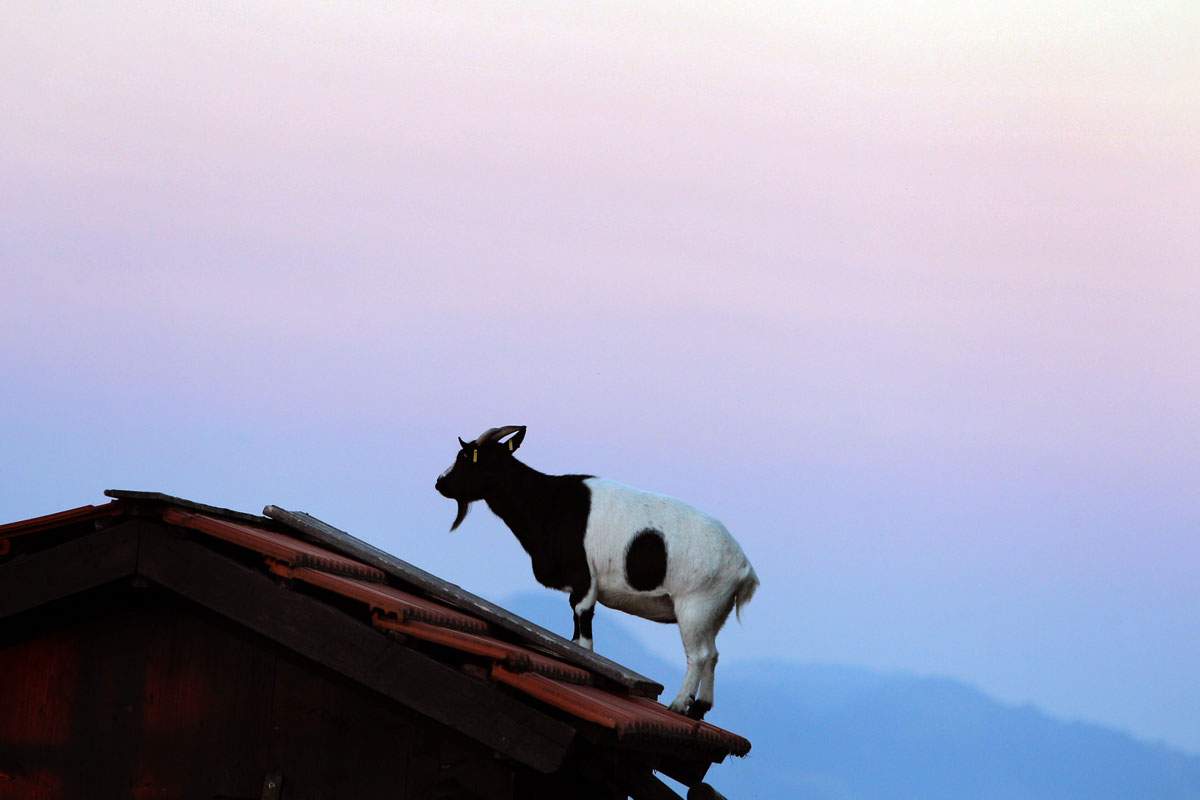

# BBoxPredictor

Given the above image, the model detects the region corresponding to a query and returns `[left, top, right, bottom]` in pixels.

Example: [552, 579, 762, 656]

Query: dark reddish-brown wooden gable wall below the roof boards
[0, 584, 516, 800]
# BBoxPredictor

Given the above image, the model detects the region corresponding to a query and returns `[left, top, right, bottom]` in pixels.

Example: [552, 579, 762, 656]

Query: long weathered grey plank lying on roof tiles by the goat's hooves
[263, 506, 662, 698]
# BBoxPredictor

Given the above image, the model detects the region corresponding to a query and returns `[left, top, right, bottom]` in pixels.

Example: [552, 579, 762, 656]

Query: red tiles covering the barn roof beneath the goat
[0, 493, 750, 760]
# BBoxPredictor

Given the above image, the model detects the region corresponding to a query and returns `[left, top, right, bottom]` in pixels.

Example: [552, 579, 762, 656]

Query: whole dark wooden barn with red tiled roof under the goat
[0, 492, 750, 800]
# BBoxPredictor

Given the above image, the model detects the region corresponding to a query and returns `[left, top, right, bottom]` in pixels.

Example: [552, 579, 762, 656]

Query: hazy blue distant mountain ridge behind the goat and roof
[502, 593, 1200, 800]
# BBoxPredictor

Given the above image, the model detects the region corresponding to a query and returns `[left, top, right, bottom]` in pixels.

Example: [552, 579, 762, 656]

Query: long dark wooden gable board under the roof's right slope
[138, 529, 575, 772]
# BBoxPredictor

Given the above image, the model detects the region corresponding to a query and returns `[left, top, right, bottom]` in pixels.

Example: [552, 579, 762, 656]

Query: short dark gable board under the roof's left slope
[0, 519, 143, 619]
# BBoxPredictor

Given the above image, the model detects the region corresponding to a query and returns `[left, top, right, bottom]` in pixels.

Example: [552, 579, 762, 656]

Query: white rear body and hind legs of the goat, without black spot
[576, 477, 758, 711]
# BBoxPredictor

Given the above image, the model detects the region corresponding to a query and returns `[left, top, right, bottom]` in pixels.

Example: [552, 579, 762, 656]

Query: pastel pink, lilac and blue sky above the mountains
[0, 0, 1200, 753]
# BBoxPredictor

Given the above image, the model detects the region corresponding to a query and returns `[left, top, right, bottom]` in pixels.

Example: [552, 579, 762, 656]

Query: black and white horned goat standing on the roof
[436, 426, 758, 720]
